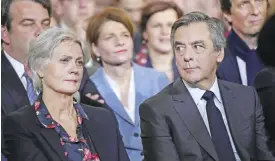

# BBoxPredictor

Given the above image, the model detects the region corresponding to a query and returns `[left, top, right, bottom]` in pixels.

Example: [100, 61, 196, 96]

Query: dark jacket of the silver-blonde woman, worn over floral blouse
[3, 104, 129, 161]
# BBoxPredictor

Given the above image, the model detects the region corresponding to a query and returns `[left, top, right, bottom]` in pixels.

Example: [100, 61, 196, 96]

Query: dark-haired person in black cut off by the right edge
[254, 15, 275, 143]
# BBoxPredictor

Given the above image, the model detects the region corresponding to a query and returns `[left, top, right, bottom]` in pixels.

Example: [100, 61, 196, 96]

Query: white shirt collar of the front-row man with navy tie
[183, 78, 222, 105]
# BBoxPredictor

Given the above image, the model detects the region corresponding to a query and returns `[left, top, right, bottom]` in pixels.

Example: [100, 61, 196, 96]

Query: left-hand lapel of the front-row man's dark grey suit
[172, 78, 218, 160]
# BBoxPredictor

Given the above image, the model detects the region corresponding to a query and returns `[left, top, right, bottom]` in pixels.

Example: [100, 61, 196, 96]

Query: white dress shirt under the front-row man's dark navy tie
[183, 78, 240, 161]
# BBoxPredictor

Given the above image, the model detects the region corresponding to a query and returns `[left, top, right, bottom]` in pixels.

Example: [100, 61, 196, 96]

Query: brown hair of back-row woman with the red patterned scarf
[140, 1, 183, 33]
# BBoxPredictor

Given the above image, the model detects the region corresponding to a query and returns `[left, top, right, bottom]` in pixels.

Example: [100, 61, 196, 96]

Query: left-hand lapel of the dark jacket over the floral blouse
[40, 125, 68, 161]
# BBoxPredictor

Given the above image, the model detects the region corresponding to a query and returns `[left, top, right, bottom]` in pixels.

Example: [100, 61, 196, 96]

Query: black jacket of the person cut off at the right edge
[255, 67, 275, 142]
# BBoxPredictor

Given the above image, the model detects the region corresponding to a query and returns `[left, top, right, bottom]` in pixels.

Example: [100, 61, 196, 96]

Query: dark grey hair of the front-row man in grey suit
[171, 12, 226, 51]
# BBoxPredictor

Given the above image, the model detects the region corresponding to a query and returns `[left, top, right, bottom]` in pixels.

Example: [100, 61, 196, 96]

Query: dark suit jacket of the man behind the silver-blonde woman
[1, 51, 102, 117]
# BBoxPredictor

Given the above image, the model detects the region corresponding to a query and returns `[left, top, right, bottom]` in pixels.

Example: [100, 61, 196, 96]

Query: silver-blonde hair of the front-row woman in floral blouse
[28, 27, 90, 93]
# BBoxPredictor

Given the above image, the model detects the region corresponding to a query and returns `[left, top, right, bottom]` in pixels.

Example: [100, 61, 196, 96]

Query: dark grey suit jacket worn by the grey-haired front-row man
[140, 79, 275, 161]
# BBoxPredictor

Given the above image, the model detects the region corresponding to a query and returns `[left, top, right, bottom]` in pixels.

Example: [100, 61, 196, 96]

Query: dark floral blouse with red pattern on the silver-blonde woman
[35, 97, 99, 161]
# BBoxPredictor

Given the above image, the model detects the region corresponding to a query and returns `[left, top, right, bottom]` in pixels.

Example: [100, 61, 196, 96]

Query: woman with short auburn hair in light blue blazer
[87, 7, 169, 161]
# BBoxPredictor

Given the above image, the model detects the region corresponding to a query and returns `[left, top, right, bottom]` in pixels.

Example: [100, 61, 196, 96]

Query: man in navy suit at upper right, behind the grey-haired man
[217, 0, 268, 86]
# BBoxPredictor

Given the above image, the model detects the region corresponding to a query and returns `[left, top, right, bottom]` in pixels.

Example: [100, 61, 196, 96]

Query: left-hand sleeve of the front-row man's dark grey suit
[140, 103, 179, 161]
